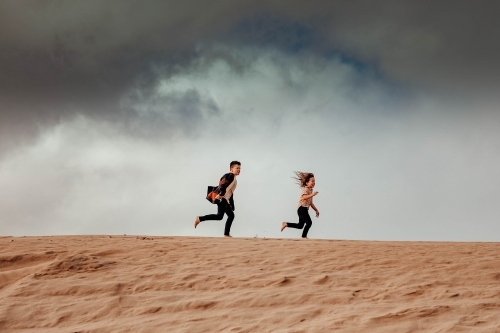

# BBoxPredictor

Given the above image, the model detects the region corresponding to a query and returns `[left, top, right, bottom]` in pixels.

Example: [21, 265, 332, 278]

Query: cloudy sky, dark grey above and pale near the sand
[0, 0, 500, 242]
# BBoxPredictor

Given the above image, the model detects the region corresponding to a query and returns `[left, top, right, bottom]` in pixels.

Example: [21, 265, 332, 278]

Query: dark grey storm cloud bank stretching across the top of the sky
[0, 0, 500, 149]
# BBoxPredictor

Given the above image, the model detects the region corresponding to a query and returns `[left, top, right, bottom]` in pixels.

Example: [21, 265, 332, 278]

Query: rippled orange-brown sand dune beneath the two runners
[0, 235, 500, 333]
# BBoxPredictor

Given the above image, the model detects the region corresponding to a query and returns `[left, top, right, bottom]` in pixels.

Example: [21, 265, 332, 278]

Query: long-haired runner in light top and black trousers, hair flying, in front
[281, 171, 319, 238]
